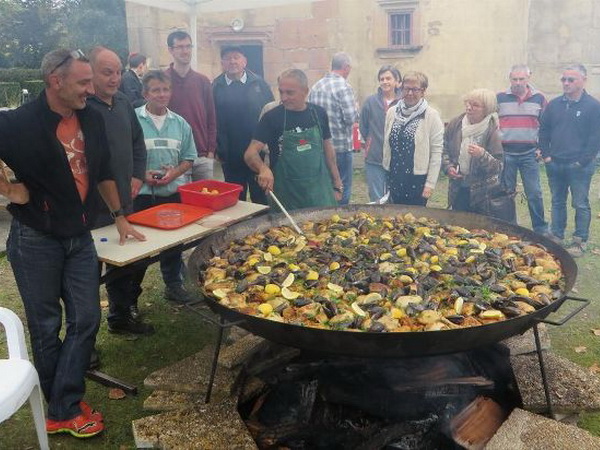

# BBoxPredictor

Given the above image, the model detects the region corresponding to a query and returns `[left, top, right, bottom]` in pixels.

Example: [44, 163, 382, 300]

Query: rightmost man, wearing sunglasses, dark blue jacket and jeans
[540, 64, 600, 257]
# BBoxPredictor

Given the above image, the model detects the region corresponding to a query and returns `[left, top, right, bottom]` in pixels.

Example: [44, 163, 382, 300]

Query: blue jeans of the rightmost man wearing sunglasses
[546, 160, 594, 242]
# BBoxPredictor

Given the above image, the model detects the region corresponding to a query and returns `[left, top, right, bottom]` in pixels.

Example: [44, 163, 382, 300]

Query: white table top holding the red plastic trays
[92, 201, 268, 266]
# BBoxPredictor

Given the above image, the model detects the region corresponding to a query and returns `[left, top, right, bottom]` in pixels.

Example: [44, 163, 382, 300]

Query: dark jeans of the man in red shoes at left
[7, 219, 100, 420]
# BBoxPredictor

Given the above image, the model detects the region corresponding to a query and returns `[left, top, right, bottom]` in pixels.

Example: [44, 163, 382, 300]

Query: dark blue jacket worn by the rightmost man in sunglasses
[539, 91, 600, 166]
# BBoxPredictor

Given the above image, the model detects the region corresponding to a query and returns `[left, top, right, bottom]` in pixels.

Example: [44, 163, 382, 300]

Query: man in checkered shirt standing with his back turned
[308, 52, 358, 205]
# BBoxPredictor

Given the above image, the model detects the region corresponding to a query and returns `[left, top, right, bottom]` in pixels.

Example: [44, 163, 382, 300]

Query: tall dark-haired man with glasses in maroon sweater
[166, 30, 217, 181]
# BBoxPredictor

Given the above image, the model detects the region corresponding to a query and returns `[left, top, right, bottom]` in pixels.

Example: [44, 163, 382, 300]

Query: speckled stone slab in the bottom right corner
[485, 409, 600, 450]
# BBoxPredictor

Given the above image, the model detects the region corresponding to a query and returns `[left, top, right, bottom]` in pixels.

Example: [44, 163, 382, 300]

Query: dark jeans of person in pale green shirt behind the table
[130, 194, 185, 303]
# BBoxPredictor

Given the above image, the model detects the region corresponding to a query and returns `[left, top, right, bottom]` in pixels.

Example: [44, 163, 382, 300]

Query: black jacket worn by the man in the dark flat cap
[213, 70, 273, 167]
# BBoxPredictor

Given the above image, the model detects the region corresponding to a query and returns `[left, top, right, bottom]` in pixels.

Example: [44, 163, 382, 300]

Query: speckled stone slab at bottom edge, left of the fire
[132, 401, 257, 450]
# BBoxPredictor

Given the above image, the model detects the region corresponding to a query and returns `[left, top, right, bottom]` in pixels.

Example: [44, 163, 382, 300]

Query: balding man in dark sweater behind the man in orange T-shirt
[87, 47, 154, 334]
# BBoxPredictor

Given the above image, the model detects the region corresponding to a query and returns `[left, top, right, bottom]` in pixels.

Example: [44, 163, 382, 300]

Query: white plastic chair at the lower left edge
[0, 307, 49, 450]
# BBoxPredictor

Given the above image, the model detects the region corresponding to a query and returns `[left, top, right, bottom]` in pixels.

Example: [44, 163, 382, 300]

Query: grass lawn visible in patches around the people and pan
[0, 166, 600, 450]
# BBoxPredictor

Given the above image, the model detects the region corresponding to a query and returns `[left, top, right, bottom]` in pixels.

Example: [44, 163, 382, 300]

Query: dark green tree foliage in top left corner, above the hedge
[0, 0, 128, 68]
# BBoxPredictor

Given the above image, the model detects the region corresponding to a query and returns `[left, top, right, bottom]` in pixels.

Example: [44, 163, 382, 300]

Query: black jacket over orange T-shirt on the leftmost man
[0, 91, 113, 237]
